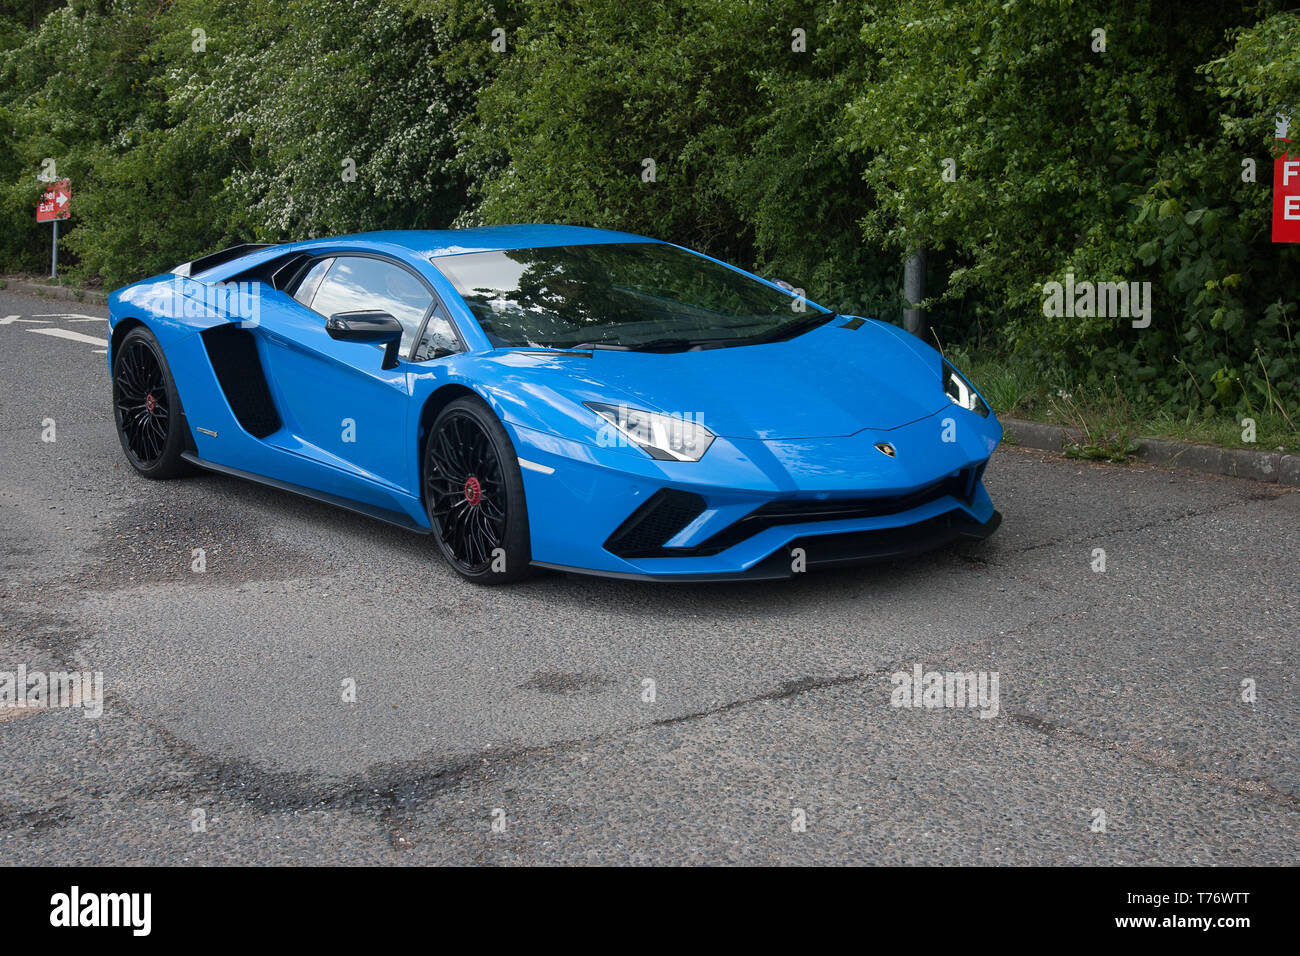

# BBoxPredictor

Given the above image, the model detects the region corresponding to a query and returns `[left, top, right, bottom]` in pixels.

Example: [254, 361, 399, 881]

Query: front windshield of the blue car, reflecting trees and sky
[433, 242, 832, 350]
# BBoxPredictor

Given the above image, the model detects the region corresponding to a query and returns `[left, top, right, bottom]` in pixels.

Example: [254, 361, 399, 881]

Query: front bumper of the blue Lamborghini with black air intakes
[507, 407, 1001, 581]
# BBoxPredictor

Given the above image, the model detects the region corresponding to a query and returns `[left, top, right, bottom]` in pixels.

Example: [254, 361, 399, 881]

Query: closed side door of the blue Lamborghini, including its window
[263, 252, 434, 492]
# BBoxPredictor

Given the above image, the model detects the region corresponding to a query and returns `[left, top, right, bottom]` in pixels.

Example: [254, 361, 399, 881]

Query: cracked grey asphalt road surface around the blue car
[0, 293, 1300, 864]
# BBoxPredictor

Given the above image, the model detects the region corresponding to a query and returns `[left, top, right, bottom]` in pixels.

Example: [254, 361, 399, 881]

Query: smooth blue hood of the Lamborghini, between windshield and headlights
[525, 317, 949, 440]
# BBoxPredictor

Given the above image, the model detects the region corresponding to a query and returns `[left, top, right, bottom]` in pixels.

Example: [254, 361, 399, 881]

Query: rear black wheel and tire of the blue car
[113, 326, 194, 479]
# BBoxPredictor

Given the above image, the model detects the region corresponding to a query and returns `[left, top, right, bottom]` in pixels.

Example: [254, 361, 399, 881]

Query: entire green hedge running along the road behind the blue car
[0, 0, 1300, 418]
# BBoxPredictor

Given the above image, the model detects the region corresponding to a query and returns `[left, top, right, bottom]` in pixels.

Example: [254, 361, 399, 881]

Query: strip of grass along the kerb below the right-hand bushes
[949, 352, 1300, 460]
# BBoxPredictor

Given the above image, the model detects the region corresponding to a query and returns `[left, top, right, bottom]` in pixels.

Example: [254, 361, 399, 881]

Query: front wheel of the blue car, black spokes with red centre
[424, 395, 533, 584]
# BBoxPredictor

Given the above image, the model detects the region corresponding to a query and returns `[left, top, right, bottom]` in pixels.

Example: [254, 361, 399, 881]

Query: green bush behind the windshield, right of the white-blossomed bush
[462, 0, 897, 312]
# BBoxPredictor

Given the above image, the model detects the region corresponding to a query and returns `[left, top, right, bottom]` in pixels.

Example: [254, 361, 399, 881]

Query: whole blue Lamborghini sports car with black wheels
[108, 225, 1002, 583]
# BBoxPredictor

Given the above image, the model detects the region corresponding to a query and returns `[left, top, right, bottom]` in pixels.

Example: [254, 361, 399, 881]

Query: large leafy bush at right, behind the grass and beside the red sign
[850, 0, 1300, 426]
